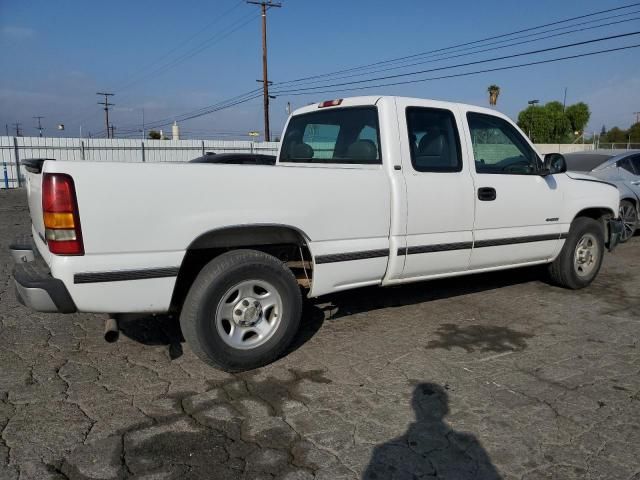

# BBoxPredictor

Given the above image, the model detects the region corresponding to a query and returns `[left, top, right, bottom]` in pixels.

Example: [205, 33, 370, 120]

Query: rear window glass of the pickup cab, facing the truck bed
[280, 106, 382, 165]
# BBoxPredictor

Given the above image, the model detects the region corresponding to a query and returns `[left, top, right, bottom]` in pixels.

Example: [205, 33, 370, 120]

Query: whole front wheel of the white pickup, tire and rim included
[549, 217, 604, 290]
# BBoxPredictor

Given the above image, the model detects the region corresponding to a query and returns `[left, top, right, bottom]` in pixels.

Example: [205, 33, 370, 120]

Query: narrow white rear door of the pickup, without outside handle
[397, 99, 474, 279]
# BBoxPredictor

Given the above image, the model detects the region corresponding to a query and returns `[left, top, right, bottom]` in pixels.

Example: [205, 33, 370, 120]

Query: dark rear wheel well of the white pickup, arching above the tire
[171, 225, 313, 311]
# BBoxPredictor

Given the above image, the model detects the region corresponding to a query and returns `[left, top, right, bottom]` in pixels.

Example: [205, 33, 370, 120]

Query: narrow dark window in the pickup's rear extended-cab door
[407, 107, 462, 172]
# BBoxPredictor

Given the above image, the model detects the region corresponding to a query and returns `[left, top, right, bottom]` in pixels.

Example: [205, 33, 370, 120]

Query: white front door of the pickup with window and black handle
[466, 111, 562, 269]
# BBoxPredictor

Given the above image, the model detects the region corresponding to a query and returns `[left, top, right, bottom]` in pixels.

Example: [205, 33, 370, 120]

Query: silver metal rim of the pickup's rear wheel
[214, 280, 282, 350]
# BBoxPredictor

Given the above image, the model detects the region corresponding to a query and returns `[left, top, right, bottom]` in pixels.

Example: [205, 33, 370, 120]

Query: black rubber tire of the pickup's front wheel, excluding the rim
[548, 217, 605, 290]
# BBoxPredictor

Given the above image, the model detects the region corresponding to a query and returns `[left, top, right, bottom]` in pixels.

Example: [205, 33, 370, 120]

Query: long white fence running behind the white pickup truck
[0, 136, 616, 189]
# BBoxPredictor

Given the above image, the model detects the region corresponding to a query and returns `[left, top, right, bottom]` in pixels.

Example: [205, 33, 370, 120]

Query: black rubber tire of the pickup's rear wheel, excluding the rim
[180, 250, 302, 372]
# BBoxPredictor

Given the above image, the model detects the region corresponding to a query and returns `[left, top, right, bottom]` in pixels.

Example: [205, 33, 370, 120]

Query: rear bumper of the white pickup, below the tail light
[9, 237, 77, 313]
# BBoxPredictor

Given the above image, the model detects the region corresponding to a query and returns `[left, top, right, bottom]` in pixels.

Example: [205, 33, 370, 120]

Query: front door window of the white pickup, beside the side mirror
[467, 112, 542, 175]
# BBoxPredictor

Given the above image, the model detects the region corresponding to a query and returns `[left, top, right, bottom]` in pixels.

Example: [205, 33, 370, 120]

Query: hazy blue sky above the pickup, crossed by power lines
[0, 0, 640, 137]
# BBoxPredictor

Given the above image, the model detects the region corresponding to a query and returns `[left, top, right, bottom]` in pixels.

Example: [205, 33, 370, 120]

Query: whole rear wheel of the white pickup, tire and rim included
[180, 250, 302, 372]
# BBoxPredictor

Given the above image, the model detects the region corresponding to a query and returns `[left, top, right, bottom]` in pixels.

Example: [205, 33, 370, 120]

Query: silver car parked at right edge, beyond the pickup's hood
[564, 150, 640, 242]
